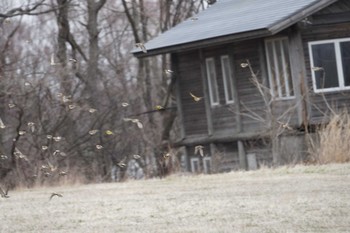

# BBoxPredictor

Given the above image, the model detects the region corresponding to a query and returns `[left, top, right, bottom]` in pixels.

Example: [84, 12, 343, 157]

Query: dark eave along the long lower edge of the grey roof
[132, 29, 272, 58]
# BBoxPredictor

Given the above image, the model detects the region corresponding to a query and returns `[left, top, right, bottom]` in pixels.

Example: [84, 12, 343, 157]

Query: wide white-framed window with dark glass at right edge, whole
[309, 38, 350, 93]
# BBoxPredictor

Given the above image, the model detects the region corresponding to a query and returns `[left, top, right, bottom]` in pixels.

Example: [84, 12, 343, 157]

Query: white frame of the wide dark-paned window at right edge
[309, 38, 350, 93]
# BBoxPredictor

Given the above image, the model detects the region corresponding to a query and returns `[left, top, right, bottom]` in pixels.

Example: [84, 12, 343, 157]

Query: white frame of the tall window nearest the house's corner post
[265, 37, 295, 100]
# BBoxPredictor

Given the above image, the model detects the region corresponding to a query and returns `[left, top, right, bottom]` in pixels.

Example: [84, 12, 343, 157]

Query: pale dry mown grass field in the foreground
[0, 164, 350, 233]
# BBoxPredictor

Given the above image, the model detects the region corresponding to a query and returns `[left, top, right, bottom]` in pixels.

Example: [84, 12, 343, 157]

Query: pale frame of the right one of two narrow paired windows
[220, 55, 235, 104]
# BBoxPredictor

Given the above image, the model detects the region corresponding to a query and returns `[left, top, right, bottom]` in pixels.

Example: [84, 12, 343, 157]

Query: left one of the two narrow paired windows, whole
[205, 58, 219, 106]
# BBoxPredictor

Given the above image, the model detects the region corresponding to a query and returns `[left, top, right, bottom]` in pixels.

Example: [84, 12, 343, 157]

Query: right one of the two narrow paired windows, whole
[221, 55, 234, 104]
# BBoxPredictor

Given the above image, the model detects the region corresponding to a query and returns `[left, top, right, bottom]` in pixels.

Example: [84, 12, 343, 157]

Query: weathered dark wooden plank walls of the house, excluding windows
[175, 0, 350, 172]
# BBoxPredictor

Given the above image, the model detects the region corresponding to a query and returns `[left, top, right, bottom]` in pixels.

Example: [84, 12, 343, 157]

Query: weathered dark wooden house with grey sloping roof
[133, 0, 350, 173]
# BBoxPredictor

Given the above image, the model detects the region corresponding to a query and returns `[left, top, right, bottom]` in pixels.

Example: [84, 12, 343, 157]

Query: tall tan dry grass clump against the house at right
[310, 111, 350, 164]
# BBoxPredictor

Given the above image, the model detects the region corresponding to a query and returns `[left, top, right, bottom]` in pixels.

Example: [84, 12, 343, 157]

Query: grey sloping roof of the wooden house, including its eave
[132, 0, 336, 56]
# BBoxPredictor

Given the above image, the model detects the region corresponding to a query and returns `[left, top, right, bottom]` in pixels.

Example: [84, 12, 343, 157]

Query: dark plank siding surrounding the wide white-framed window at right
[301, 0, 350, 124]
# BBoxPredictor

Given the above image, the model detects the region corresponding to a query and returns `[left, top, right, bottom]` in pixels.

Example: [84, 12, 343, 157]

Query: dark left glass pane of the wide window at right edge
[312, 43, 339, 89]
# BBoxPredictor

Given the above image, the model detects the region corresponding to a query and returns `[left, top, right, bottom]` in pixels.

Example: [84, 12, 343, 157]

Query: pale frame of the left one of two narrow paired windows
[205, 57, 220, 106]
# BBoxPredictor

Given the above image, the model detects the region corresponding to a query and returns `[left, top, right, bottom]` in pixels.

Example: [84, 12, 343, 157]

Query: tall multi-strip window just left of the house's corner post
[265, 38, 294, 99]
